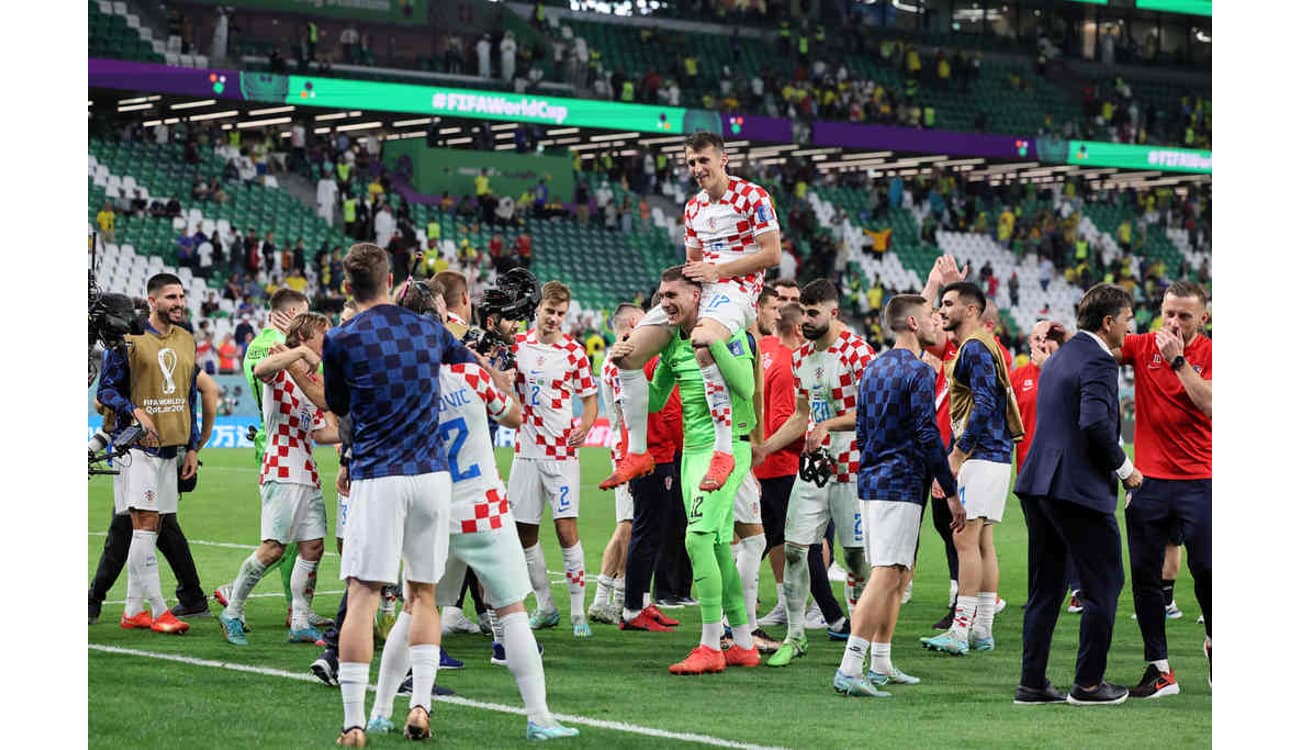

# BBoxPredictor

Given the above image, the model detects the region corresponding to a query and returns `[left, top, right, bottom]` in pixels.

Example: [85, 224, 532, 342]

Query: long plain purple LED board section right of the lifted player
[813, 120, 1037, 160]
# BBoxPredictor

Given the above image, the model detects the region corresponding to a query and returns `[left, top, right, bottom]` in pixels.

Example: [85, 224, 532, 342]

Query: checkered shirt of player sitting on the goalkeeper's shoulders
[683, 177, 781, 304]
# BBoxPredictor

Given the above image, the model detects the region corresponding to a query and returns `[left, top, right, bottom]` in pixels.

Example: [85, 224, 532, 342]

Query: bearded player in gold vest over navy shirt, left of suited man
[920, 281, 1024, 655]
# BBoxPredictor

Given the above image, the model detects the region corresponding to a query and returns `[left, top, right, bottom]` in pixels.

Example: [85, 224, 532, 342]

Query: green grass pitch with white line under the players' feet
[87, 448, 1212, 749]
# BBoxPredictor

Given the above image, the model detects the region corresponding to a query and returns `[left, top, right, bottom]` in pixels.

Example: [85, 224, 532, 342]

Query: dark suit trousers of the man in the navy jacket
[1021, 495, 1125, 689]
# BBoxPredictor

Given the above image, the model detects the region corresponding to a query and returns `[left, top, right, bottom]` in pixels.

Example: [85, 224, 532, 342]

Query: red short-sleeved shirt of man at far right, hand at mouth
[1123, 333, 1213, 480]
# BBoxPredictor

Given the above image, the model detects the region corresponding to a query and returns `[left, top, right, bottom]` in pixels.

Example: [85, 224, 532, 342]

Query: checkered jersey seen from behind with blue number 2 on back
[438, 364, 514, 534]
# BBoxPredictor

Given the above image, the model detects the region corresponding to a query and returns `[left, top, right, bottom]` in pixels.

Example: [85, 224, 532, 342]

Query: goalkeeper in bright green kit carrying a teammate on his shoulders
[610, 265, 759, 675]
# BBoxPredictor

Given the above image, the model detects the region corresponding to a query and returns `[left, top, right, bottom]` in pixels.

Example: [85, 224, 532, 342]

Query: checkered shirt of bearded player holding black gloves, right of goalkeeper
[794, 329, 876, 482]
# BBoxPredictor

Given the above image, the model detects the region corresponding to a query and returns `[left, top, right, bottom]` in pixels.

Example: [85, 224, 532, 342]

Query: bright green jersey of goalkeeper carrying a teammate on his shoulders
[650, 330, 757, 451]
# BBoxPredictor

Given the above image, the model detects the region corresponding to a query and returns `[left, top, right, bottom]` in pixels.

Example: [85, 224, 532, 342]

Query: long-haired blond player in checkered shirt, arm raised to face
[218, 312, 338, 646]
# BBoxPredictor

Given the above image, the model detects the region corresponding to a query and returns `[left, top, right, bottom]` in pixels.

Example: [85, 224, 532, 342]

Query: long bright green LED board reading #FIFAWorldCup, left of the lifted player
[287, 73, 686, 134]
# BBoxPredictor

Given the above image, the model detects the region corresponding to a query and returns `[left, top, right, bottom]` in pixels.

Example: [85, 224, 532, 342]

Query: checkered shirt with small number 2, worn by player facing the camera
[515, 329, 597, 460]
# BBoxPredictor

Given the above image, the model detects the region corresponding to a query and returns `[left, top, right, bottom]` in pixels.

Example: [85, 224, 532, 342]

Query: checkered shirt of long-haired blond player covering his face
[259, 370, 325, 489]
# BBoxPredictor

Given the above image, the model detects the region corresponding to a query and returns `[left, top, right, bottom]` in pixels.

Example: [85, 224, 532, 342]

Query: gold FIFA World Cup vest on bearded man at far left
[126, 325, 195, 447]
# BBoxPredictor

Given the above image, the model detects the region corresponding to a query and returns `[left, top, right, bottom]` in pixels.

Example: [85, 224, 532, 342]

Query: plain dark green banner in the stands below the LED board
[384, 138, 573, 205]
